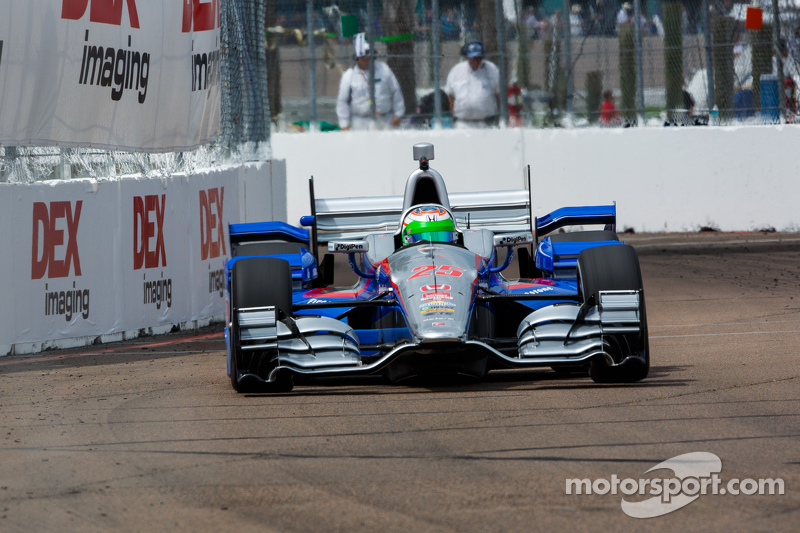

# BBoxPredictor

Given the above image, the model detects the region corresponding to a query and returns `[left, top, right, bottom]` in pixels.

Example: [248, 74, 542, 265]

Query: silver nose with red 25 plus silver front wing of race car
[230, 249, 645, 381]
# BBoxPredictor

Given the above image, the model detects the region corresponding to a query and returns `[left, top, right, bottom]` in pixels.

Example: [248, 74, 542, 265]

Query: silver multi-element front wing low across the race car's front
[226, 291, 647, 382]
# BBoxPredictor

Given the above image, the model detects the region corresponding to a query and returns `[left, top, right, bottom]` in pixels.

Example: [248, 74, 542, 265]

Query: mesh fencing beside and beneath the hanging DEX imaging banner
[0, 0, 271, 183]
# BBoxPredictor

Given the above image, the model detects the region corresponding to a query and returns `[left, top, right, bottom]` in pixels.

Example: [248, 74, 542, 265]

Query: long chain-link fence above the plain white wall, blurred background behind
[266, 0, 800, 131]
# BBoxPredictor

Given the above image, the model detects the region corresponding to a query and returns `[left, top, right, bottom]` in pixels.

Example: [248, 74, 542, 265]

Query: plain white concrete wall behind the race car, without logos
[272, 126, 800, 232]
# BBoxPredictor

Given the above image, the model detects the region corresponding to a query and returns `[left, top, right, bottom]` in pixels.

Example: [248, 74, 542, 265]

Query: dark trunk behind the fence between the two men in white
[383, 0, 417, 113]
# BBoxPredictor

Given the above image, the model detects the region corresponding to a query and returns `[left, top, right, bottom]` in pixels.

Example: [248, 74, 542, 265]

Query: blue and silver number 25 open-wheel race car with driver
[225, 143, 650, 392]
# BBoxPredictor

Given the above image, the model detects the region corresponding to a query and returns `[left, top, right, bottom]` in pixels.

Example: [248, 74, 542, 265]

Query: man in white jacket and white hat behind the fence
[336, 33, 406, 131]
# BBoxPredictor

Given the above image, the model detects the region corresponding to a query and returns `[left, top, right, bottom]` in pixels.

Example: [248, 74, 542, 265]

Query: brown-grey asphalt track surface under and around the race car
[0, 234, 800, 532]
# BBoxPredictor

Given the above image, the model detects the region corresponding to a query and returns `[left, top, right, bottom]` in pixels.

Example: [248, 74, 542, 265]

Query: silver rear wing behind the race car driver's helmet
[300, 189, 532, 242]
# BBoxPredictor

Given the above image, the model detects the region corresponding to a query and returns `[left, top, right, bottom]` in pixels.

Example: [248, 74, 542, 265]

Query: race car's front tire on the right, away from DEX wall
[578, 245, 650, 383]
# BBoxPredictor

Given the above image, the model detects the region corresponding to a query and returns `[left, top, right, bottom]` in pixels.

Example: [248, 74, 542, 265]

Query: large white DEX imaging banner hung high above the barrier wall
[0, 0, 220, 152]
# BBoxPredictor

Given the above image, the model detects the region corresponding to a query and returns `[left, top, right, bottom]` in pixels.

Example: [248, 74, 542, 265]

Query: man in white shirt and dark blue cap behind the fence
[444, 41, 500, 128]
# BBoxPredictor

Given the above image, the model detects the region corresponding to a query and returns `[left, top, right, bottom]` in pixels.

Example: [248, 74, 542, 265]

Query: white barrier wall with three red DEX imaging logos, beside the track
[0, 161, 286, 355]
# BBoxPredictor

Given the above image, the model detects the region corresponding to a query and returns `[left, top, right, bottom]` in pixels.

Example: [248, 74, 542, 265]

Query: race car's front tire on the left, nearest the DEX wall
[231, 257, 294, 393]
